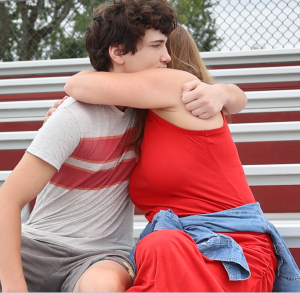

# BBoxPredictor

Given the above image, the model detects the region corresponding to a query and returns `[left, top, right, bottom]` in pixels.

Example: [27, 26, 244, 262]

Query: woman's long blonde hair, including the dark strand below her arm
[129, 24, 213, 154]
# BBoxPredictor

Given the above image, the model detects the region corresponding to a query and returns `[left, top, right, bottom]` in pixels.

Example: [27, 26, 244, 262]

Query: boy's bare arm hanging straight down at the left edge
[0, 153, 56, 292]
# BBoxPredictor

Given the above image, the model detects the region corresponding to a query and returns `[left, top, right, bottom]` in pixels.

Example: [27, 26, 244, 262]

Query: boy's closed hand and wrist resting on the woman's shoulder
[182, 80, 247, 119]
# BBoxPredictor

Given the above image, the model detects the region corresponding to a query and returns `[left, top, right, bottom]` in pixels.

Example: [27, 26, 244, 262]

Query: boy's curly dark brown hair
[85, 0, 178, 71]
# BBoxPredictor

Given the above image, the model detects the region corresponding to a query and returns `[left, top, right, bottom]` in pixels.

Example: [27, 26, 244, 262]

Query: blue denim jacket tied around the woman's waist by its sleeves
[130, 203, 300, 292]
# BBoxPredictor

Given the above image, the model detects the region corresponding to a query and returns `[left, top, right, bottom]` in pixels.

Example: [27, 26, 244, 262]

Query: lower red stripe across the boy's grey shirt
[50, 158, 136, 190]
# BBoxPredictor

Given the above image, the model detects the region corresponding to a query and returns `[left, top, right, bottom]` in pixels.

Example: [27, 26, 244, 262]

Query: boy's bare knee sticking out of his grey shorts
[74, 260, 132, 292]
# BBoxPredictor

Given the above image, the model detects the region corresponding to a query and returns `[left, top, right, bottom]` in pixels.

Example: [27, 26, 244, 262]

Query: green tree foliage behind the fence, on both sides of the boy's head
[0, 0, 219, 61]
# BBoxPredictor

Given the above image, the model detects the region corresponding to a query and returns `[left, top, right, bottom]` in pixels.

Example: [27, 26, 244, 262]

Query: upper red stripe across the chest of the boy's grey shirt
[70, 128, 133, 164]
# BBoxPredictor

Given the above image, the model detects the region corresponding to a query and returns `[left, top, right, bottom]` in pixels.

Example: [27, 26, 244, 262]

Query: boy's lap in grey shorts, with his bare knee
[18, 236, 134, 292]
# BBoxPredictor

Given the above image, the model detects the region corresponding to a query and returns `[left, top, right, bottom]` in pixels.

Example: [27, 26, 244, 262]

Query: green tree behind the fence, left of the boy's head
[0, 0, 104, 61]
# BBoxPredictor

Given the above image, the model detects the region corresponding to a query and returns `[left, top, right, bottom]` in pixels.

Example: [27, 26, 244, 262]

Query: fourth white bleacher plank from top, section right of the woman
[229, 121, 300, 142]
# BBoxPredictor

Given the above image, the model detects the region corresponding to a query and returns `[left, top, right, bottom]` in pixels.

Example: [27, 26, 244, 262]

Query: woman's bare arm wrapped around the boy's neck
[65, 68, 197, 109]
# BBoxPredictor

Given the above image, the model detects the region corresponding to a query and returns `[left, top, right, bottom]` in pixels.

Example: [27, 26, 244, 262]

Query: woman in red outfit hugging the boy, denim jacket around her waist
[65, 26, 299, 292]
